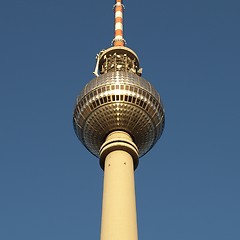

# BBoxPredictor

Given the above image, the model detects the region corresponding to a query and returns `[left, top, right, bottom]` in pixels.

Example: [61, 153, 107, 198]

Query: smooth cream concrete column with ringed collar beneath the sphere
[100, 131, 138, 240]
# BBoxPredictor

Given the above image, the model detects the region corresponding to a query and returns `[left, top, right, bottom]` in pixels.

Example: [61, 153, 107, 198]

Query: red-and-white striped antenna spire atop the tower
[113, 0, 126, 46]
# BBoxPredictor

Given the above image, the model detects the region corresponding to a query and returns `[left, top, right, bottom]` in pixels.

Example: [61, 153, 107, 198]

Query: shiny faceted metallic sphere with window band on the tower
[73, 71, 165, 157]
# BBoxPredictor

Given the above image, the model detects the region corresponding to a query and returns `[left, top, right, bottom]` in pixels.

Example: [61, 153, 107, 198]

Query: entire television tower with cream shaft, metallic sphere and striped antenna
[73, 0, 165, 240]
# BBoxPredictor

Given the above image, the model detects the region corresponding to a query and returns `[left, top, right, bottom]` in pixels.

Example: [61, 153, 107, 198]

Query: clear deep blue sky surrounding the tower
[0, 0, 240, 240]
